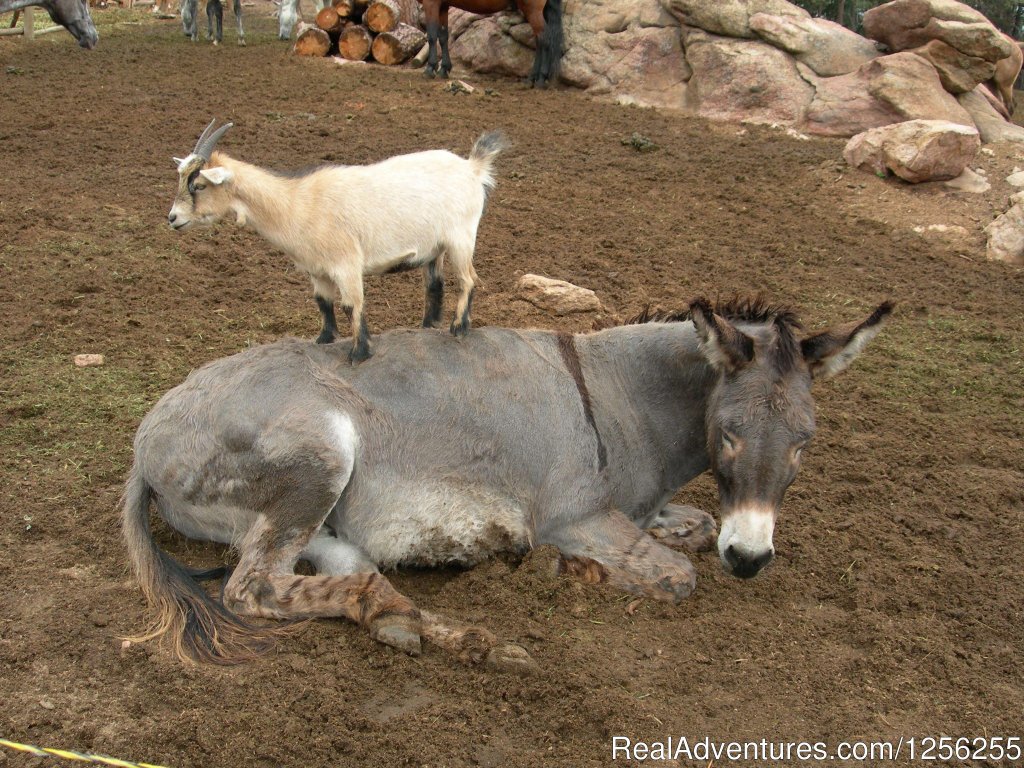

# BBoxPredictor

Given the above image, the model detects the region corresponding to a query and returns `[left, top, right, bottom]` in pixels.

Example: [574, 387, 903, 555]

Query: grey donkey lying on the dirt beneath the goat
[123, 300, 891, 668]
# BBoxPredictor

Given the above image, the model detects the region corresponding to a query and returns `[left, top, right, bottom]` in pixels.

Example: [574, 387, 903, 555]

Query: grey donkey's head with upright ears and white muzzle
[690, 299, 892, 579]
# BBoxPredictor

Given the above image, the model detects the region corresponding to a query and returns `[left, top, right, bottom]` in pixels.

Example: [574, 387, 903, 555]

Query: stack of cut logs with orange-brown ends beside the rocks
[293, 0, 427, 66]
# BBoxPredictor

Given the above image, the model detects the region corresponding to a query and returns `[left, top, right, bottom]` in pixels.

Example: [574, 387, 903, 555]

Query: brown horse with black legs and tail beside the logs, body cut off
[420, 0, 562, 88]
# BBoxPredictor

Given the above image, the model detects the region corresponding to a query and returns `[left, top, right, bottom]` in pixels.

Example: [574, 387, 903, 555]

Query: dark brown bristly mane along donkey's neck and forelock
[623, 294, 804, 374]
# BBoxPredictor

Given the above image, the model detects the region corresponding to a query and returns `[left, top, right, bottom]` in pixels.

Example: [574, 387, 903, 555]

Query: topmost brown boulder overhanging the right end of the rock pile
[863, 0, 1012, 63]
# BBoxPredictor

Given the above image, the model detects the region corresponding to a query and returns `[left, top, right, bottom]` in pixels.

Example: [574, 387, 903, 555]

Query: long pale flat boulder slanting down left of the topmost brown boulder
[750, 13, 880, 77]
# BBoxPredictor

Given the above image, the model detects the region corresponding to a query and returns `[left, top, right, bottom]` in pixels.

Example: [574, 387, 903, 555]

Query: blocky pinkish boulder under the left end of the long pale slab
[686, 30, 814, 125]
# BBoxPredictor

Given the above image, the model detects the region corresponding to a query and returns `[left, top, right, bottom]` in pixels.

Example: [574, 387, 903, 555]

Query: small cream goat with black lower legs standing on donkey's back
[167, 121, 507, 362]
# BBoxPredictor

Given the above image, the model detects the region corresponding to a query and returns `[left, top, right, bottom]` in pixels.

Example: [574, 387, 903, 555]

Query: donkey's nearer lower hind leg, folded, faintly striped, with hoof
[224, 518, 420, 655]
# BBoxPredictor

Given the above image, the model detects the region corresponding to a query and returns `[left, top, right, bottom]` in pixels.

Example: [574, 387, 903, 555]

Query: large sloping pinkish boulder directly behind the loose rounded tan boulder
[803, 52, 974, 136]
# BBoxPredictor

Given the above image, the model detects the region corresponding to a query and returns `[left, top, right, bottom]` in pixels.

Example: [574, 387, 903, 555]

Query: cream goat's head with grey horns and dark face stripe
[167, 120, 233, 229]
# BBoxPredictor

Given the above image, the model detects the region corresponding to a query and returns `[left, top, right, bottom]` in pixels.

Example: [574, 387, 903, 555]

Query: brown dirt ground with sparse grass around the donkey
[0, 4, 1024, 768]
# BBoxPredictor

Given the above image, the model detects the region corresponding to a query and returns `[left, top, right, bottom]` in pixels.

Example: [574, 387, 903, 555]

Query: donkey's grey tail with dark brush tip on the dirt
[121, 464, 281, 665]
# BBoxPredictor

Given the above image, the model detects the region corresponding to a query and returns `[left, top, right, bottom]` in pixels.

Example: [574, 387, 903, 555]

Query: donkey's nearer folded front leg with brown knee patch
[541, 510, 696, 602]
